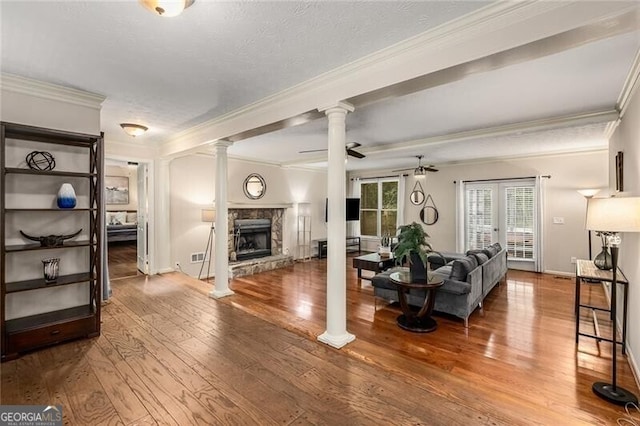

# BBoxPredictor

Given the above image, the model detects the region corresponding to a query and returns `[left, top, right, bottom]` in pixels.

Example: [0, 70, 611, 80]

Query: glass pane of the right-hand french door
[505, 186, 534, 259]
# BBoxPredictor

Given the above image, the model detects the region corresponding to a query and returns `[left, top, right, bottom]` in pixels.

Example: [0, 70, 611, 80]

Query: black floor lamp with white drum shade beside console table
[576, 197, 640, 405]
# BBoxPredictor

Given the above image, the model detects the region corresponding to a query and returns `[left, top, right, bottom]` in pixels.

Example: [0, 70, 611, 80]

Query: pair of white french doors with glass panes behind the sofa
[464, 179, 540, 271]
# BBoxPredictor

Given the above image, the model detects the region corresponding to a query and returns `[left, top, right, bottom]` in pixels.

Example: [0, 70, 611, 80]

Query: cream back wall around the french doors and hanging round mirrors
[354, 151, 608, 273]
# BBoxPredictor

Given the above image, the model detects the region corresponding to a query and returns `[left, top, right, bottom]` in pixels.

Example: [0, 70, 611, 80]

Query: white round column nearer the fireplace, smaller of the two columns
[209, 141, 233, 299]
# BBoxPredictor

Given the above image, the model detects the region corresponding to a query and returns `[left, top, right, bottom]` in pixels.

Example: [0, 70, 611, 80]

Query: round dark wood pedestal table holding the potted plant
[389, 269, 444, 333]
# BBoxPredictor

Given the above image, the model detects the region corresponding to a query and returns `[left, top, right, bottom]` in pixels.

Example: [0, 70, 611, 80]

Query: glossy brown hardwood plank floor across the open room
[0, 255, 638, 425]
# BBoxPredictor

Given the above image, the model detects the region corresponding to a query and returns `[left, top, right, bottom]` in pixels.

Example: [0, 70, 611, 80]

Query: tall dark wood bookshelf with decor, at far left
[0, 122, 104, 361]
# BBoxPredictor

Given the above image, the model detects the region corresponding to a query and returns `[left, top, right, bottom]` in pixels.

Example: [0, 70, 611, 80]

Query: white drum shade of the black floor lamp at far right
[586, 197, 640, 232]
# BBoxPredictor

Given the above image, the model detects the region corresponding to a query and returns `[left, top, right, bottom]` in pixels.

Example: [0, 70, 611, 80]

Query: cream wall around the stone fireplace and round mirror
[169, 155, 327, 277]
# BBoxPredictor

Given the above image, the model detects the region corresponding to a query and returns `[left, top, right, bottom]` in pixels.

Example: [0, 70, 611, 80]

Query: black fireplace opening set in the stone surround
[233, 219, 271, 260]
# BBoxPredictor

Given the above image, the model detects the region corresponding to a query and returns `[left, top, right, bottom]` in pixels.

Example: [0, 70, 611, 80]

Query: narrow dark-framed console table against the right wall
[575, 259, 629, 354]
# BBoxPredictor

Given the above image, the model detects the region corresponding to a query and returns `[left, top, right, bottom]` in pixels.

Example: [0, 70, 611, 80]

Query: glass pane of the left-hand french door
[465, 188, 493, 250]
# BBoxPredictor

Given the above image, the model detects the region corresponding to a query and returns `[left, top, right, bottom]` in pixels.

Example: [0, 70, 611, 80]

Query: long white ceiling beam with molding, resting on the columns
[161, 1, 633, 155]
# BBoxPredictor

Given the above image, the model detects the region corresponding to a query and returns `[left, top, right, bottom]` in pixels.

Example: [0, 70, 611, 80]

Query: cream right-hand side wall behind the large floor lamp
[609, 85, 640, 382]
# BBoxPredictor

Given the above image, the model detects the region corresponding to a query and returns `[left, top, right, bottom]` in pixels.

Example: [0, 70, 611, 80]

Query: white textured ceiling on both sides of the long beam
[0, 0, 640, 170]
